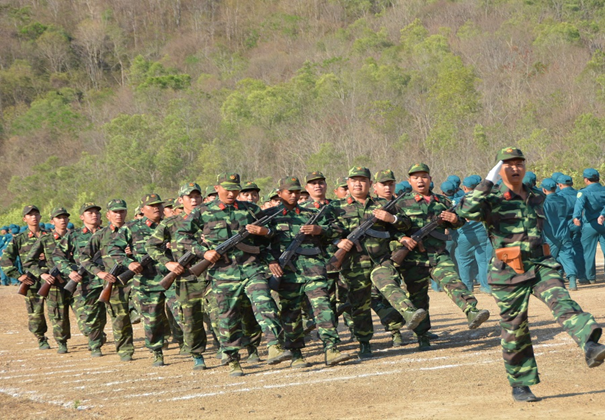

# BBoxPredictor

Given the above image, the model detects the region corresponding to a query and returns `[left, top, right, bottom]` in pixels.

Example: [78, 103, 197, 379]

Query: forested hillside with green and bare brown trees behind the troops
[0, 0, 605, 223]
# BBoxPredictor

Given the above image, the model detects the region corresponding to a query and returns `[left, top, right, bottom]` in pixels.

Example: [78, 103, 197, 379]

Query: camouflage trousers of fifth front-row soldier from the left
[137, 289, 170, 351]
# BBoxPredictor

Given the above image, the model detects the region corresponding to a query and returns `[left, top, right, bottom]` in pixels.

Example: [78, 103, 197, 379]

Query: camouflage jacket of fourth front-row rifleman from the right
[188, 199, 268, 280]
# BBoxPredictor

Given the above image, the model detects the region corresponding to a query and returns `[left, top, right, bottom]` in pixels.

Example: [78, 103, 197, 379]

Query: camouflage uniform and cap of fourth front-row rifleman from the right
[187, 174, 281, 361]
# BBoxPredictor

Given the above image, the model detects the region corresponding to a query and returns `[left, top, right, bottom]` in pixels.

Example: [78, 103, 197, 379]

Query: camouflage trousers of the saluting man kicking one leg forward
[490, 265, 601, 386]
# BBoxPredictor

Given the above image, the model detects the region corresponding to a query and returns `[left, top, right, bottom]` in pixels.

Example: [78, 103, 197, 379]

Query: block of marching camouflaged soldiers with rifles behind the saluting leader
[0, 164, 489, 376]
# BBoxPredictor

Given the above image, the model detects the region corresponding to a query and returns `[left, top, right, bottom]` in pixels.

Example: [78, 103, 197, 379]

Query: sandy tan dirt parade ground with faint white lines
[0, 262, 605, 419]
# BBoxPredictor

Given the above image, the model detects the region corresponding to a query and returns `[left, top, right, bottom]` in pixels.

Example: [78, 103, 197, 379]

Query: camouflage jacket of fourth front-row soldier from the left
[80, 223, 135, 286]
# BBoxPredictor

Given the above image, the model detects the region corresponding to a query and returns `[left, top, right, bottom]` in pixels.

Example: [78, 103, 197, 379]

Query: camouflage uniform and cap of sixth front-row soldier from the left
[146, 183, 208, 360]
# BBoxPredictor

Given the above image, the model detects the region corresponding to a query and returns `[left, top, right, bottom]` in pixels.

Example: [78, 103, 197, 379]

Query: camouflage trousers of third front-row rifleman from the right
[278, 279, 340, 349]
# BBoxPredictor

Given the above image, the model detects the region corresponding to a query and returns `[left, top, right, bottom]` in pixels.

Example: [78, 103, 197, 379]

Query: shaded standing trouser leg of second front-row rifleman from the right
[341, 261, 374, 342]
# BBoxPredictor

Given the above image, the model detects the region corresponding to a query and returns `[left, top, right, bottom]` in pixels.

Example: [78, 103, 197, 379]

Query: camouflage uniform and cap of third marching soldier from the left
[52, 208, 107, 352]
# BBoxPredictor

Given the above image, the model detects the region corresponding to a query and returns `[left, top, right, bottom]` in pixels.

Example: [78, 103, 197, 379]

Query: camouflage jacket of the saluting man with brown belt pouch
[458, 180, 560, 284]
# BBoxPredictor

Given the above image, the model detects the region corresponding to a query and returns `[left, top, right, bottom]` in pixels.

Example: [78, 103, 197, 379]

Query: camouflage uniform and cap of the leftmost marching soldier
[0, 206, 49, 348]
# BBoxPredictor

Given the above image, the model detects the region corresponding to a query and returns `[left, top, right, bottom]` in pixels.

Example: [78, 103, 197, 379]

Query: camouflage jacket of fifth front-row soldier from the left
[126, 217, 170, 292]
